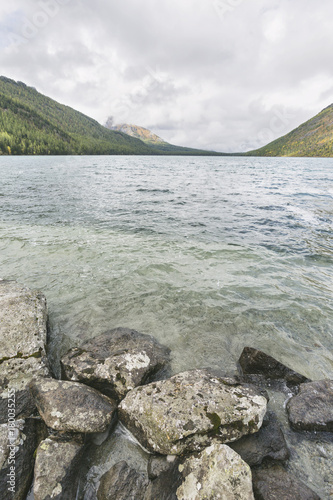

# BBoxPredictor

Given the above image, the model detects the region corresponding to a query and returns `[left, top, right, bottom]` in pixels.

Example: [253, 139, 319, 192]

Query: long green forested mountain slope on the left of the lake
[0, 76, 223, 155]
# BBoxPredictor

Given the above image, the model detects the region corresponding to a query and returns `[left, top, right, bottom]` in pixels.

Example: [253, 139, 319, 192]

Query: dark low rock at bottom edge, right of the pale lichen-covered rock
[252, 466, 320, 500]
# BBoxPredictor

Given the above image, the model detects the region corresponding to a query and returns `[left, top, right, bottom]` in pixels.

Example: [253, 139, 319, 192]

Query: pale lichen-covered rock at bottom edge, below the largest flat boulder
[176, 443, 254, 500]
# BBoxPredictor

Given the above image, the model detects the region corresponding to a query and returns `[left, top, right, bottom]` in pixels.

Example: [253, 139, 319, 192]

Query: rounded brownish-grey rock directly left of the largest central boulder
[30, 379, 116, 433]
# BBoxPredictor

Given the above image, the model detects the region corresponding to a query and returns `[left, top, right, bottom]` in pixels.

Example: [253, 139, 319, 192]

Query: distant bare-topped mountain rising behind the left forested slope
[105, 116, 224, 156]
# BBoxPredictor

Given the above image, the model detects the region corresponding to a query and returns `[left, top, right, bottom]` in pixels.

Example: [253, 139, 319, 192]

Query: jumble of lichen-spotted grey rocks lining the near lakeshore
[0, 280, 333, 500]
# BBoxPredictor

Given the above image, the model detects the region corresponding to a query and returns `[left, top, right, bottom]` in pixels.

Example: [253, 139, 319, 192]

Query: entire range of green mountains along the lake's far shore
[0, 76, 333, 157]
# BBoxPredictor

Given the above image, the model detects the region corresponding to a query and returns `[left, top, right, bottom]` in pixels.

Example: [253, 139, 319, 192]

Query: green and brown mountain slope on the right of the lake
[245, 104, 333, 157]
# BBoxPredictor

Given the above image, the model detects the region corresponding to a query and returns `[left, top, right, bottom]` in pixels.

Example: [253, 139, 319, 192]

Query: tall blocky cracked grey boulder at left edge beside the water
[0, 280, 50, 423]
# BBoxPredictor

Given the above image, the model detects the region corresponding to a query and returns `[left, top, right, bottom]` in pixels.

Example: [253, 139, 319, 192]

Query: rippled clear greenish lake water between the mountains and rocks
[0, 156, 333, 494]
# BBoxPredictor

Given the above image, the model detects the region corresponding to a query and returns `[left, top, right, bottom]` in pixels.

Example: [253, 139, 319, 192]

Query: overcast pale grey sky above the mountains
[0, 0, 333, 152]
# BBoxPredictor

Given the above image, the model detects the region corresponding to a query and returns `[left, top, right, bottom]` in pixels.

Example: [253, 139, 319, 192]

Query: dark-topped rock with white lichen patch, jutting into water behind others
[61, 328, 170, 400]
